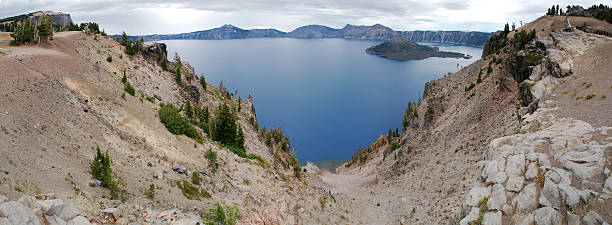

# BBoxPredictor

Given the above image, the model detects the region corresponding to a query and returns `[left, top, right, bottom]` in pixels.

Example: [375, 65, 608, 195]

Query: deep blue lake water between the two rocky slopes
[162, 38, 482, 162]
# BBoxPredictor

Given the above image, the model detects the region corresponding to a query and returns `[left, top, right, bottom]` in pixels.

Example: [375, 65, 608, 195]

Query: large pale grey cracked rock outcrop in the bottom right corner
[461, 100, 612, 225]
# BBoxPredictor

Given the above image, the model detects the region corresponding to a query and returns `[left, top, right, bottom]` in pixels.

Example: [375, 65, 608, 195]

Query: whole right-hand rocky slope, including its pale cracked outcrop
[322, 16, 612, 225]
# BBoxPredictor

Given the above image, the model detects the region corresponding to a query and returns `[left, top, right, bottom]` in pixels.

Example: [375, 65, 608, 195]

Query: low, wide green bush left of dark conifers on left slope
[159, 103, 202, 141]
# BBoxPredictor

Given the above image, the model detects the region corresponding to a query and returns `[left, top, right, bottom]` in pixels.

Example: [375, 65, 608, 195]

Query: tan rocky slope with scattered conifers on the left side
[0, 32, 343, 224]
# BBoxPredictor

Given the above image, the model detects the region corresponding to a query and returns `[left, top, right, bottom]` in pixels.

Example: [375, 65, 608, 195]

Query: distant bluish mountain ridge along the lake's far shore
[122, 24, 493, 47]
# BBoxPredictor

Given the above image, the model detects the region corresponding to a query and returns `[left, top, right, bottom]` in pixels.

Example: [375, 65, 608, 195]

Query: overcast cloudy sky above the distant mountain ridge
[0, 0, 611, 35]
